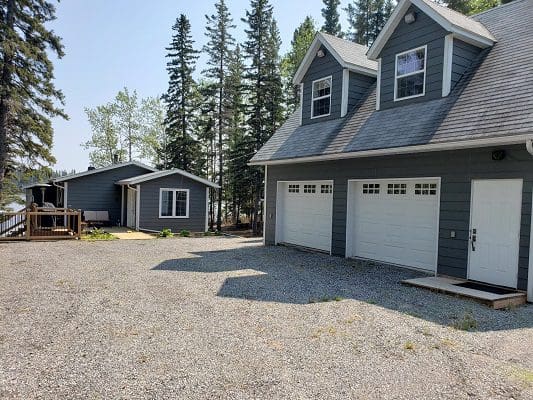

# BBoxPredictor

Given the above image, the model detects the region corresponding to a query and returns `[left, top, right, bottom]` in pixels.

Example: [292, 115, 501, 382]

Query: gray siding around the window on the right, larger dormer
[379, 6, 448, 110]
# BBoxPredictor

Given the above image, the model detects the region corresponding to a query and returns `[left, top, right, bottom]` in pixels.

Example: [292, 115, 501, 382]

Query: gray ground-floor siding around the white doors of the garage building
[265, 146, 533, 290]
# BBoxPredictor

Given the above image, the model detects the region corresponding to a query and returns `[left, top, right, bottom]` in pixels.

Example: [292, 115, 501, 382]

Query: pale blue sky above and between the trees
[50, 0, 348, 171]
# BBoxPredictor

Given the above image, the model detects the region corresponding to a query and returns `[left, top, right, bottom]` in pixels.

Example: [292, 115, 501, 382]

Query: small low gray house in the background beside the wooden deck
[26, 161, 218, 232]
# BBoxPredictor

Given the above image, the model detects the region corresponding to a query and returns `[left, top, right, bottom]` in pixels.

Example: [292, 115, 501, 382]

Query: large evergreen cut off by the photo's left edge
[0, 0, 67, 207]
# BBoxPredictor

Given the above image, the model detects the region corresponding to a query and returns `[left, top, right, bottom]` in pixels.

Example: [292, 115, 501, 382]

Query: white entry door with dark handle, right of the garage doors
[468, 179, 522, 288]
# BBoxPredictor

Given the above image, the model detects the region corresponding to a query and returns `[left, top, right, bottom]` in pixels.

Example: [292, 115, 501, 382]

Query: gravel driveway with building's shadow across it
[0, 238, 533, 399]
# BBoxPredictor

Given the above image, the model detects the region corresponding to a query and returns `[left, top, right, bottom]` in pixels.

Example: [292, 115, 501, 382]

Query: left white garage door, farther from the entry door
[276, 181, 333, 252]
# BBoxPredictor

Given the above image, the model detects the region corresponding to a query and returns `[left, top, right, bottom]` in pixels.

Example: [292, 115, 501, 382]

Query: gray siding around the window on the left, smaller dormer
[302, 47, 342, 125]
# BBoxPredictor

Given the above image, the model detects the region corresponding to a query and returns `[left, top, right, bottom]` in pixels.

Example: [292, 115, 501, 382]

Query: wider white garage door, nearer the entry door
[347, 180, 440, 271]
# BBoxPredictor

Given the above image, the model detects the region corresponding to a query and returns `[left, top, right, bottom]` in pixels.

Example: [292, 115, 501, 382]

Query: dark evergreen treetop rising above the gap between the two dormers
[346, 0, 394, 46]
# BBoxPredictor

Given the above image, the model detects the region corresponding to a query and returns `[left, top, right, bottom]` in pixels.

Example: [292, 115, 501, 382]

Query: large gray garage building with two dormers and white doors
[251, 0, 533, 301]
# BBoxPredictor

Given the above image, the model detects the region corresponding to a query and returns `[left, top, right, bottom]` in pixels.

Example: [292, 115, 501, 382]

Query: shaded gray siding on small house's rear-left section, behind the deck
[67, 165, 152, 225]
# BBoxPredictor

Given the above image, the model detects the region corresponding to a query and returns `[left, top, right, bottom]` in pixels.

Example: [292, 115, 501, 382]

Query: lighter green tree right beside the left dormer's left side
[280, 16, 316, 117]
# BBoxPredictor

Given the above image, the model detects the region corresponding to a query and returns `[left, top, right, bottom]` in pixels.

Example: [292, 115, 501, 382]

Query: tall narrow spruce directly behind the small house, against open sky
[163, 14, 201, 173]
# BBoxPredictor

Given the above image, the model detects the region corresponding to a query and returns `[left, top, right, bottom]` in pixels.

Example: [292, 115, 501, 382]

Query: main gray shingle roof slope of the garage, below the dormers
[251, 0, 533, 162]
